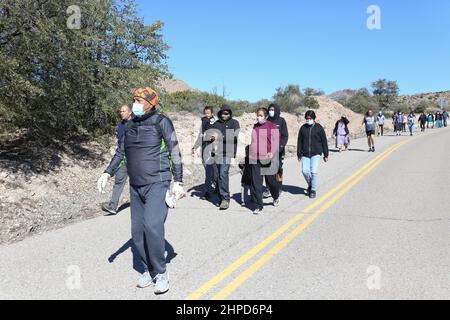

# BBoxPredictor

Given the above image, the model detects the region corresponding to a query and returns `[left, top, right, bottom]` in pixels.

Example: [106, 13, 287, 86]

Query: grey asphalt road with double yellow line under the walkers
[0, 129, 450, 299]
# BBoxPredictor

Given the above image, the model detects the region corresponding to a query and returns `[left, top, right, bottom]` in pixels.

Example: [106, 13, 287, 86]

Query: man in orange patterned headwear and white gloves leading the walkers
[97, 88, 185, 294]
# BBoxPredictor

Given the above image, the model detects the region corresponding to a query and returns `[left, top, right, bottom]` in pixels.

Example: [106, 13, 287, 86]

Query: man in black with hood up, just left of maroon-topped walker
[213, 105, 240, 210]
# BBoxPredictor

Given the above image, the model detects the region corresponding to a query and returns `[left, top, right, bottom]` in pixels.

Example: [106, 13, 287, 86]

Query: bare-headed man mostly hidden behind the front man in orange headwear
[102, 105, 133, 215]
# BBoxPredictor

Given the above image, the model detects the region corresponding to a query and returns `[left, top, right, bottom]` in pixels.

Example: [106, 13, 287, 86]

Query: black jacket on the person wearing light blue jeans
[297, 123, 329, 159]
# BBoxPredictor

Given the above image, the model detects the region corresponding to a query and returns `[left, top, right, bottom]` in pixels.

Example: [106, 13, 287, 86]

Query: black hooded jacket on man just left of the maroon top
[212, 106, 241, 158]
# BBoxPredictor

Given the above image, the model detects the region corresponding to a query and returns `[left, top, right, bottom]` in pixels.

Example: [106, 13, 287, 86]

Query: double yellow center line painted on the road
[186, 140, 412, 300]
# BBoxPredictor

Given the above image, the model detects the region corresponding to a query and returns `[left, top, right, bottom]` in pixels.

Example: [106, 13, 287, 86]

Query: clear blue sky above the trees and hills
[137, 0, 450, 101]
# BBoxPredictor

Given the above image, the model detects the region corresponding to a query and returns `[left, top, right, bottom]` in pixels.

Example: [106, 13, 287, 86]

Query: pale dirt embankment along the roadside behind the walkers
[0, 97, 388, 243]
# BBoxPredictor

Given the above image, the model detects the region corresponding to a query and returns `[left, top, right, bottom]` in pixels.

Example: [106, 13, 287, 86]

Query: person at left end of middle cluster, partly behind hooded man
[192, 106, 218, 200]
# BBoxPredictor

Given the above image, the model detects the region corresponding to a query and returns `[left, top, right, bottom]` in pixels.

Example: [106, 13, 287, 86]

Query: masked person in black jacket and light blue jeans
[297, 110, 329, 199]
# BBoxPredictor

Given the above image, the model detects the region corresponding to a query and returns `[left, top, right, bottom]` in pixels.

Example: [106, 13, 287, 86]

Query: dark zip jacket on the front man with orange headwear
[105, 112, 183, 187]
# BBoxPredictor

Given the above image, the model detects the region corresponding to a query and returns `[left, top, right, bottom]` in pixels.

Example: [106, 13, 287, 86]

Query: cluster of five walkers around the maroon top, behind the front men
[192, 104, 329, 215]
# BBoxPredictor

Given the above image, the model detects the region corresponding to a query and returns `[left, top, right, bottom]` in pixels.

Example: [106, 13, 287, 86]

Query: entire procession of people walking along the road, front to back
[97, 87, 448, 294]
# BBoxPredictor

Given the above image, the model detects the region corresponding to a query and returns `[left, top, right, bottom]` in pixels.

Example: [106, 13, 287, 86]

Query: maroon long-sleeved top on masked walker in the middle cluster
[250, 121, 280, 160]
